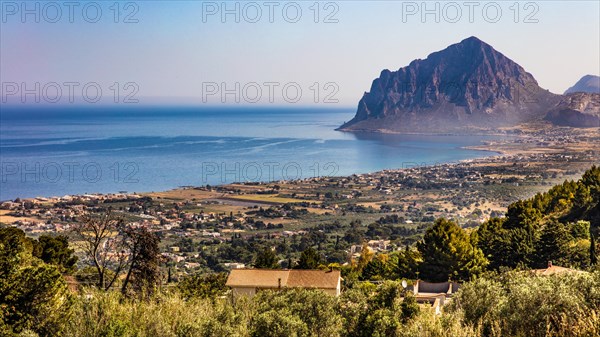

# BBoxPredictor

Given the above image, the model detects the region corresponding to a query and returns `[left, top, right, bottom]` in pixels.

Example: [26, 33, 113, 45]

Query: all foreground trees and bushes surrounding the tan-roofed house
[0, 167, 600, 336]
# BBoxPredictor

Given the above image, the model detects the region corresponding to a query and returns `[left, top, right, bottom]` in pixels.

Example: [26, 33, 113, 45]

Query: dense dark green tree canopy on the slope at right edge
[477, 166, 600, 270]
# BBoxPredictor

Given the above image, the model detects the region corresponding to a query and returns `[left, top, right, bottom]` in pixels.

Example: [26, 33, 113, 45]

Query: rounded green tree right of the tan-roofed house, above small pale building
[417, 218, 488, 282]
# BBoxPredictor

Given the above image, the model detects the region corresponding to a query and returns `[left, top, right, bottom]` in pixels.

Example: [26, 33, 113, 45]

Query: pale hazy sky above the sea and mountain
[0, 0, 600, 107]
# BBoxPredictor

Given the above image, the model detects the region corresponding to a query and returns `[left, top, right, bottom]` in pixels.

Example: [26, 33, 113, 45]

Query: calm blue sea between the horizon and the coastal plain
[0, 106, 494, 200]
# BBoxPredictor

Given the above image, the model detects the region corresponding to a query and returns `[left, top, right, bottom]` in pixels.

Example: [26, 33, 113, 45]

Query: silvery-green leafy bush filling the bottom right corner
[450, 271, 600, 337]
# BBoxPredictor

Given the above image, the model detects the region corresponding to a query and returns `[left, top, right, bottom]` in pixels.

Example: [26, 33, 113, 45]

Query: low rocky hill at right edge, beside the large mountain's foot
[545, 92, 600, 127]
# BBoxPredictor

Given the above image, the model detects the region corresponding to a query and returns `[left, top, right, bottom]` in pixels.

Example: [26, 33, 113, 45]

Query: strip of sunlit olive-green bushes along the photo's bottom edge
[5, 271, 600, 337]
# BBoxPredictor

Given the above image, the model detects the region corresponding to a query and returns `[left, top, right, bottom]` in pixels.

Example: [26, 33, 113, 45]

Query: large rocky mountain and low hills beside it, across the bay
[339, 37, 600, 133]
